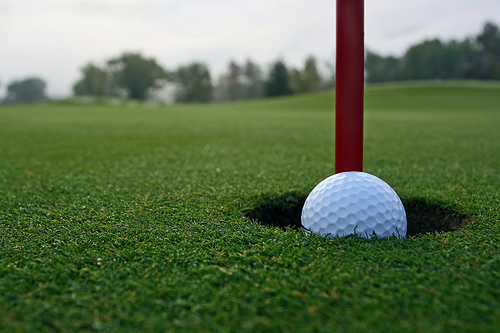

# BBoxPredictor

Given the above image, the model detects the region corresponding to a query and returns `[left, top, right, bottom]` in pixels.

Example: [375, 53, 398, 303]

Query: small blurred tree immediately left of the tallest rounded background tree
[73, 63, 107, 97]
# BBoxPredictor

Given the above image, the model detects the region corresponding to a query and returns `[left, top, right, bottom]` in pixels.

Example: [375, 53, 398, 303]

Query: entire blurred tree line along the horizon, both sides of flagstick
[2, 22, 500, 103]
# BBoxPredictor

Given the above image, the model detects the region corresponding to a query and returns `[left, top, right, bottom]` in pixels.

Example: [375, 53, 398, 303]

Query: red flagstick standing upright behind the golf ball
[335, 0, 365, 173]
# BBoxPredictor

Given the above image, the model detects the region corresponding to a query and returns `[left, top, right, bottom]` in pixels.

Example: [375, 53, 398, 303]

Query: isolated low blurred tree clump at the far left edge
[4, 77, 47, 103]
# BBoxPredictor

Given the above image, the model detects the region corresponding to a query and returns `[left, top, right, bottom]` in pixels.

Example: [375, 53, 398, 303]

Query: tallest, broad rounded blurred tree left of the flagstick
[108, 53, 167, 100]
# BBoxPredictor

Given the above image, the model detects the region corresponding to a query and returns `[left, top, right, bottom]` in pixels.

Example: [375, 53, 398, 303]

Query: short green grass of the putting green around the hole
[0, 82, 500, 332]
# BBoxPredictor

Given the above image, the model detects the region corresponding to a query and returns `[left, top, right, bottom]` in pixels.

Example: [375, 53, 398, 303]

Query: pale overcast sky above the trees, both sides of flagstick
[0, 0, 500, 96]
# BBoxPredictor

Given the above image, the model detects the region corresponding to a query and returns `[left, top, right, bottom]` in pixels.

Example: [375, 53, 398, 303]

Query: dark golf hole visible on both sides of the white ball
[245, 193, 470, 237]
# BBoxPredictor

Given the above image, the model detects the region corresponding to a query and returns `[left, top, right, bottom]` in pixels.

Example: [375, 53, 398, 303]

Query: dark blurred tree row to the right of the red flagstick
[365, 22, 500, 83]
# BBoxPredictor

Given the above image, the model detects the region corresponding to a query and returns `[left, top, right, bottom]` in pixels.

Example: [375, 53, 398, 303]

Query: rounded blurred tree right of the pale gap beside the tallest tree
[171, 62, 213, 103]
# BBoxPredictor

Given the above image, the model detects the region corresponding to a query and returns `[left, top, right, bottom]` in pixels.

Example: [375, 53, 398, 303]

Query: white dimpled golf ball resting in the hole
[301, 171, 407, 238]
